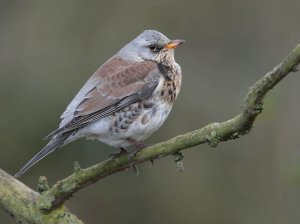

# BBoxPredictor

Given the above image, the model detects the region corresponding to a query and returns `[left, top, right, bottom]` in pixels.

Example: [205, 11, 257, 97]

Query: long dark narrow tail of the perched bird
[15, 134, 70, 177]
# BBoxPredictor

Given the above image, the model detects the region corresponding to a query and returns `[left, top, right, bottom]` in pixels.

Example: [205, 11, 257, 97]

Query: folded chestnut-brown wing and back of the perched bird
[47, 59, 159, 139]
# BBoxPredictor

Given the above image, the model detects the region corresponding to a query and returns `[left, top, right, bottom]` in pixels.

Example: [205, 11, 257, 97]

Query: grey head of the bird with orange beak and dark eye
[118, 30, 184, 63]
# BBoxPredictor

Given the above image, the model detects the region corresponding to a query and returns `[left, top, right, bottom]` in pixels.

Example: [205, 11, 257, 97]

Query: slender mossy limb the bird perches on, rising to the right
[38, 45, 300, 211]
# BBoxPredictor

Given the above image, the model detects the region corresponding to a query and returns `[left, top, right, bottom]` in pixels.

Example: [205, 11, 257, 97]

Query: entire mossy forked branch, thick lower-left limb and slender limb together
[0, 44, 300, 224]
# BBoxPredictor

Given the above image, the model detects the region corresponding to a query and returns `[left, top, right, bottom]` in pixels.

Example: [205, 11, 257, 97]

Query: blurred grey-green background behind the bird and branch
[0, 0, 300, 224]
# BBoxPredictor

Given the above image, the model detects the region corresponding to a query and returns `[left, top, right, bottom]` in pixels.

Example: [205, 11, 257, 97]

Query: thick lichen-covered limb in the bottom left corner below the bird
[0, 169, 83, 224]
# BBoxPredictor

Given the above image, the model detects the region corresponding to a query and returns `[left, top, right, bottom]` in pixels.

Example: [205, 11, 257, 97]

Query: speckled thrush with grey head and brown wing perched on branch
[15, 30, 184, 177]
